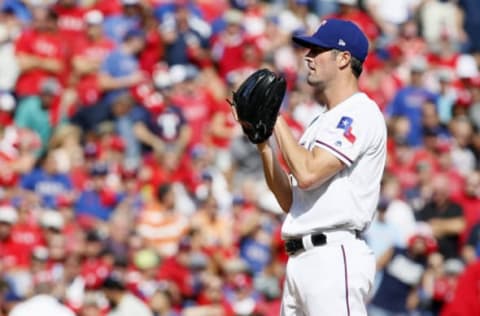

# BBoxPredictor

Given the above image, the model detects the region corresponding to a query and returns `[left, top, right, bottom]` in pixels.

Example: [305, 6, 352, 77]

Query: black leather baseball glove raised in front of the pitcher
[227, 69, 286, 144]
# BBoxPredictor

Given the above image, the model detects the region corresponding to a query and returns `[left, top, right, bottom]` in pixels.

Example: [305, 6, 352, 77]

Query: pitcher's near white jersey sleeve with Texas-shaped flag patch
[313, 115, 365, 167]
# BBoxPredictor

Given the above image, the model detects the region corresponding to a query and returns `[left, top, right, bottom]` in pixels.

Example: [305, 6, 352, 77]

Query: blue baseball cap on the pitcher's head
[292, 19, 368, 62]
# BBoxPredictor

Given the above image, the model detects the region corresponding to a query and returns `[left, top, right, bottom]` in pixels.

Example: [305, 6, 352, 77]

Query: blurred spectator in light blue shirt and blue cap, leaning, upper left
[98, 28, 146, 107]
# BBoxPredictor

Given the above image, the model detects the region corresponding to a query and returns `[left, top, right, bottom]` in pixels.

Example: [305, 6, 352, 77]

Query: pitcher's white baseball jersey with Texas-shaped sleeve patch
[282, 92, 387, 236]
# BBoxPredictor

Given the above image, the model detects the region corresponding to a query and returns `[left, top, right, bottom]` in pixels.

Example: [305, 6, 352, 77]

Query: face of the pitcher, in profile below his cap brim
[305, 47, 336, 88]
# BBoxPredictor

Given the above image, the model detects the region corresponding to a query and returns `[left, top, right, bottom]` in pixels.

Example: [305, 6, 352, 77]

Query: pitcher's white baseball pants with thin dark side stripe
[281, 231, 375, 316]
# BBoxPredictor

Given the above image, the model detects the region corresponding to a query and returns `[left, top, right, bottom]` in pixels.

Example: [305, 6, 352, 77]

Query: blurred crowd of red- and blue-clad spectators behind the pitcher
[0, 0, 480, 316]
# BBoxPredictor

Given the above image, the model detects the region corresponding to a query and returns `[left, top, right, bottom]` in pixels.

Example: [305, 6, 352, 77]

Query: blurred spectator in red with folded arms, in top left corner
[15, 4, 67, 98]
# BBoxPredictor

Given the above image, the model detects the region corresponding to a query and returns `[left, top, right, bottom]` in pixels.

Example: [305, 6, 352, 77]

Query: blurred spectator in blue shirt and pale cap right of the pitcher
[386, 57, 437, 146]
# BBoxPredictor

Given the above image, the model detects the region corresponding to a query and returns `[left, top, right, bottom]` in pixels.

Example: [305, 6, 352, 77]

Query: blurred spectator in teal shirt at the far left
[15, 77, 66, 154]
